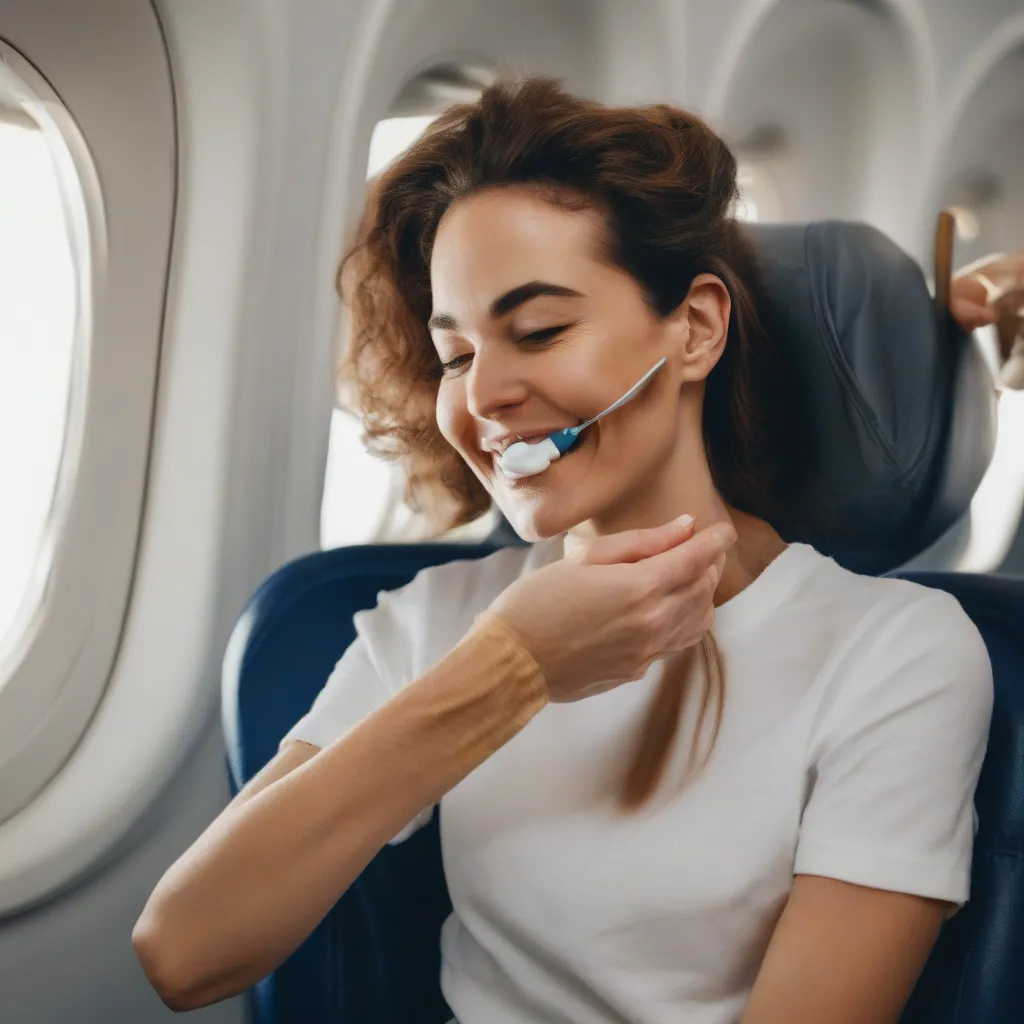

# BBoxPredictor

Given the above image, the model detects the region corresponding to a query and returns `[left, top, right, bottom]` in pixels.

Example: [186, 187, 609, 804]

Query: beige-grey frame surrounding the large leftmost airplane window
[0, 24, 176, 822]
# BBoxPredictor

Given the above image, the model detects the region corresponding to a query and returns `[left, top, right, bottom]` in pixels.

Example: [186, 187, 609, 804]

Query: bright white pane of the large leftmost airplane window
[0, 90, 85, 647]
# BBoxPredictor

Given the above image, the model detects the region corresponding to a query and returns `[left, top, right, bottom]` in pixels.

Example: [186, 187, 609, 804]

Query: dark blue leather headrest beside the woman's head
[744, 221, 995, 573]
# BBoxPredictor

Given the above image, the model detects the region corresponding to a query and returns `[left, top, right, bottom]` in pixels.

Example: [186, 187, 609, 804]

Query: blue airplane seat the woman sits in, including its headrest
[222, 221, 1024, 1024]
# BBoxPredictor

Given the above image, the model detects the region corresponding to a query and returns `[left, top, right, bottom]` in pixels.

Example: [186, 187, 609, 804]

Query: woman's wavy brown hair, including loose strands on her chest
[338, 77, 784, 807]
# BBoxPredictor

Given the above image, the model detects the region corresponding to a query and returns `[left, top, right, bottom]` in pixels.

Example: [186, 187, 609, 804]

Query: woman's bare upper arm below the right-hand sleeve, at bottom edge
[742, 874, 948, 1024]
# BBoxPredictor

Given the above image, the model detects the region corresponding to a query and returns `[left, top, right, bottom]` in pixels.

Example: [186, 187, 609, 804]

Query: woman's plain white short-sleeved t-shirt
[280, 539, 992, 1024]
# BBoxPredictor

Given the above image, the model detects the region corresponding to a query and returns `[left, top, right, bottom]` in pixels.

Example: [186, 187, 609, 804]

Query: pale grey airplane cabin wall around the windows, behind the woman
[0, 0, 1024, 1024]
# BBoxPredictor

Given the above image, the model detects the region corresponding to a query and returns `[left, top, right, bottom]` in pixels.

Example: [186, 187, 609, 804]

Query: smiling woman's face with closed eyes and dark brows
[430, 188, 728, 541]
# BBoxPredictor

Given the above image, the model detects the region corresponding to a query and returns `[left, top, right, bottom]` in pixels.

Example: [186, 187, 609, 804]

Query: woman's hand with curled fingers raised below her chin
[489, 520, 736, 702]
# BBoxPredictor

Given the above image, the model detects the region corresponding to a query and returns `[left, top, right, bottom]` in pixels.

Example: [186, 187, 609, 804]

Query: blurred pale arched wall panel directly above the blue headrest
[708, 0, 931, 247]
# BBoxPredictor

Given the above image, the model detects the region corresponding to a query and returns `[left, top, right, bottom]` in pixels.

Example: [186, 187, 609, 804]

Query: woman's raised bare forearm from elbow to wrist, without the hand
[132, 618, 546, 1010]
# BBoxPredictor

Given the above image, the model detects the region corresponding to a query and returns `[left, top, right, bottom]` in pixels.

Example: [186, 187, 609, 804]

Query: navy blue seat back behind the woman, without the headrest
[223, 545, 1024, 1024]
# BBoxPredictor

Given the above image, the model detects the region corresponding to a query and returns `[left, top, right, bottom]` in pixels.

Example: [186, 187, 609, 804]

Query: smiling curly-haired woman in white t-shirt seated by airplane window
[133, 79, 991, 1024]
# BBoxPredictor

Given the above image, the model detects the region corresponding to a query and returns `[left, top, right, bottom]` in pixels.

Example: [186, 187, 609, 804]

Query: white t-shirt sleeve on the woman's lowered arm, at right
[795, 591, 992, 905]
